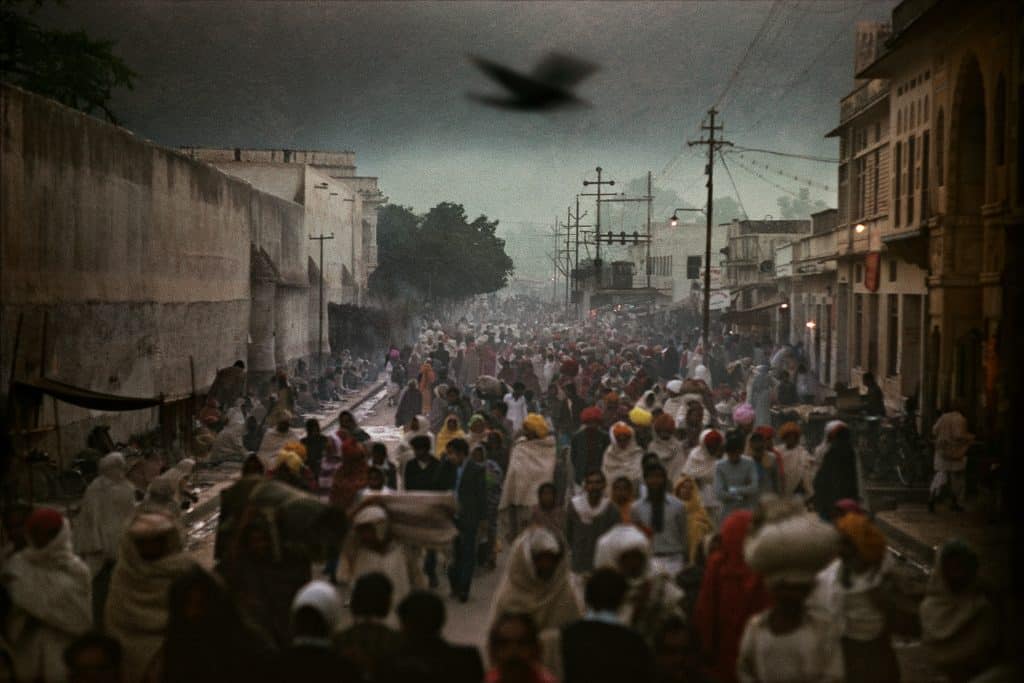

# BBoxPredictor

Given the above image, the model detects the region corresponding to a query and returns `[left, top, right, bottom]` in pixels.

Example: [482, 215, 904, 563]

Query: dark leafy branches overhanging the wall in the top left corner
[0, 0, 137, 123]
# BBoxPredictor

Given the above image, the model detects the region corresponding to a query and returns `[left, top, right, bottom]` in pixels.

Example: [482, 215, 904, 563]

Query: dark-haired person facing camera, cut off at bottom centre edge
[483, 612, 558, 683]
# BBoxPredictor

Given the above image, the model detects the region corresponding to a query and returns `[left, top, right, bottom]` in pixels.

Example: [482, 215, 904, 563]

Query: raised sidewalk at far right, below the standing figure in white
[876, 501, 1013, 590]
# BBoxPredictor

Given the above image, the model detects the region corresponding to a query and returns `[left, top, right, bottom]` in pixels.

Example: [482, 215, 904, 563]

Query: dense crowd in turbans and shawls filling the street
[0, 302, 1013, 683]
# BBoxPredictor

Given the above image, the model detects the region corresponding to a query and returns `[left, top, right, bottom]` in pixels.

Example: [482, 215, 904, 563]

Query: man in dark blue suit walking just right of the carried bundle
[441, 437, 487, 602]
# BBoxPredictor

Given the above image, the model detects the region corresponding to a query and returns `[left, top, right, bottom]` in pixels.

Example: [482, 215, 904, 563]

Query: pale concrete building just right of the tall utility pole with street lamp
[720, 220, 811, 339]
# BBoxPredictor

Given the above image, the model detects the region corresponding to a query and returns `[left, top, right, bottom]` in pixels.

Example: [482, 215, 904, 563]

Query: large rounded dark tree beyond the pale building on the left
[370, 202, 513, 300]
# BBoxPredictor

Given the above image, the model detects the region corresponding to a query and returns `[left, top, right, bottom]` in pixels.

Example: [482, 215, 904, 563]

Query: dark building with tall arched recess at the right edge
[857, 0, 1024, 434]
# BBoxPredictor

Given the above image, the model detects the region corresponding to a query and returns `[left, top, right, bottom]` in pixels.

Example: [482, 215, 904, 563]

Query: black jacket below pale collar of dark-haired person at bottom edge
[561, 620, 654, 683]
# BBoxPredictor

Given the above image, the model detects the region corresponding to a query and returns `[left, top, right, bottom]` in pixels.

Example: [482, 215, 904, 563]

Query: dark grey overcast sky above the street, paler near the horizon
[36, 0, 893, 229]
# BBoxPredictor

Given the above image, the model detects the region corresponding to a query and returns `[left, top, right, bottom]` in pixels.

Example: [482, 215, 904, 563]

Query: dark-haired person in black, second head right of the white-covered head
[378, 591, 483, 683]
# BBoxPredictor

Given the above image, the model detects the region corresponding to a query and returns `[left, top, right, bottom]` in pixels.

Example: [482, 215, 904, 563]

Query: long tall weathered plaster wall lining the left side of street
[0, 85, 309, 452]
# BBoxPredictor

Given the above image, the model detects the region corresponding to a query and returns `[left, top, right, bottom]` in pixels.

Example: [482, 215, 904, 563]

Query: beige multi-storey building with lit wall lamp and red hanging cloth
[827, 22, 930, 410]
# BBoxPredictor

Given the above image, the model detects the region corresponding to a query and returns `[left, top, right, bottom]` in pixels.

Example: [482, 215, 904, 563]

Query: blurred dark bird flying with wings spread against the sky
[469, 52, 597, 112]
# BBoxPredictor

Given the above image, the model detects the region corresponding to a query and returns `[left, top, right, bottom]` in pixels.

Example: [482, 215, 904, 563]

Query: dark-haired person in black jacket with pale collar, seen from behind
[560, 568, 653, 683]
